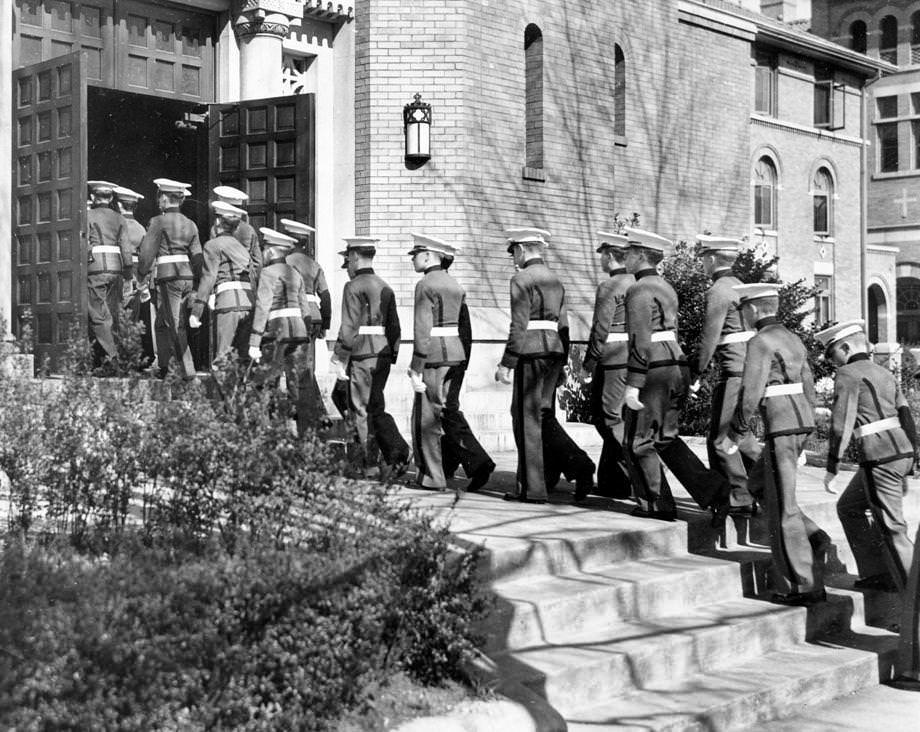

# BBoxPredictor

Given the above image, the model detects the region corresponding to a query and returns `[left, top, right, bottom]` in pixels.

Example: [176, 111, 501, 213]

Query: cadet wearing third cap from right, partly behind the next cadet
[690, 234, 761, 516]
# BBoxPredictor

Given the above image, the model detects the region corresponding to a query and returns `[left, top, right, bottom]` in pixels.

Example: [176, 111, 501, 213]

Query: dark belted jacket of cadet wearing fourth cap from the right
[626, 269, 685, 389]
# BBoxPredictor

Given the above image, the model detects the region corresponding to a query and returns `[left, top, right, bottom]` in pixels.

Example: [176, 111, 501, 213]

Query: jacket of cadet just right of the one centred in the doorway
[192, 234, 254, 318]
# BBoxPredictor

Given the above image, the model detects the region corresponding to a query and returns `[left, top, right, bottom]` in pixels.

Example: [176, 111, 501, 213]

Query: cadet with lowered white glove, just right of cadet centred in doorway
[188, 201, 253, 361]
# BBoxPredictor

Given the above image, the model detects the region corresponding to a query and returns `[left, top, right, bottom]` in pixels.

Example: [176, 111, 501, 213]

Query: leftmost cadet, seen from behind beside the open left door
[86, 180, 133, 366]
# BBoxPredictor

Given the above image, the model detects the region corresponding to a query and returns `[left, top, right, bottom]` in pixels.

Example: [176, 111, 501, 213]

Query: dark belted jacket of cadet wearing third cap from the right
[692, 269, 747, 377]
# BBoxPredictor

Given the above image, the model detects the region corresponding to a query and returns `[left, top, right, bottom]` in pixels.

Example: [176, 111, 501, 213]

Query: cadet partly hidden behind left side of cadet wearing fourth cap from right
[576, 231, 636, 498]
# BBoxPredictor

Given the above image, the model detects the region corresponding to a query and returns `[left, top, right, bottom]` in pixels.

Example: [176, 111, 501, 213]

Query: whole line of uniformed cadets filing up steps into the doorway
[82, 184, 920, 688]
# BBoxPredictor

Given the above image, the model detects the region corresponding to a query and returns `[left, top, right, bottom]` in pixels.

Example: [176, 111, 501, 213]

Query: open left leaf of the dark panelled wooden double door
[13, 53, 86, 361]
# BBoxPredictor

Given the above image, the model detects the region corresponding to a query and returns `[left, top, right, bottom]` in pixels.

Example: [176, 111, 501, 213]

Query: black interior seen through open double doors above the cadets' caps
[86, 87, 209, 369]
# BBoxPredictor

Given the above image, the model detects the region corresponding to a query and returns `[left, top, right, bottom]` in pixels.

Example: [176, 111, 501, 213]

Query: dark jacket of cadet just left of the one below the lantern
[334, 267, 402, 363]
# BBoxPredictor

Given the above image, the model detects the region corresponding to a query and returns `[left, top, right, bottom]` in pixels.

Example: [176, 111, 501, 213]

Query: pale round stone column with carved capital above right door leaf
[234, 0, 303, 101]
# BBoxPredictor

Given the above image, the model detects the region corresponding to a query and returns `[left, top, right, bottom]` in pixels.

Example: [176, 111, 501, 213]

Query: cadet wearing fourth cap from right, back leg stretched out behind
[623, 229, 729, 524]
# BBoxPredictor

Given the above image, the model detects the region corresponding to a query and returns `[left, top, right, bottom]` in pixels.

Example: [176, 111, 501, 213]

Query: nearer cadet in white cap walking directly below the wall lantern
[409, 232, 495, 491]
